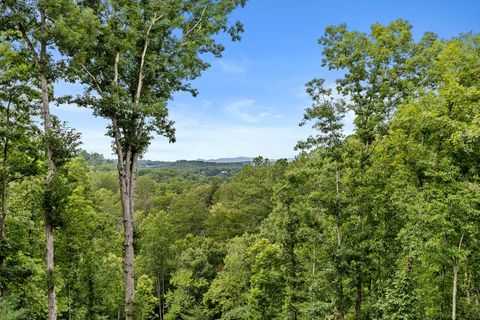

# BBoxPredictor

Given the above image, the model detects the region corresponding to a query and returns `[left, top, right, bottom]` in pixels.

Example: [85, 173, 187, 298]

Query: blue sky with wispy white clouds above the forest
[53, 0, 480, 161]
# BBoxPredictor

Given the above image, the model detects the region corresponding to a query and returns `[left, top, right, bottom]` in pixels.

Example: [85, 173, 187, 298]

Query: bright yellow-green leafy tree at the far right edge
[395, 35, 479, 319]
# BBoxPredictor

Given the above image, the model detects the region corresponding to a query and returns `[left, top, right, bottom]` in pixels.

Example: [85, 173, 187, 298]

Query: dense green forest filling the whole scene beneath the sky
[0, 0, 480, 320]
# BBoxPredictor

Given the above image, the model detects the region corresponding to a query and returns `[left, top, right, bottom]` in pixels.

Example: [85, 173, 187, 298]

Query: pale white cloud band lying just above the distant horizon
[76, 99, 318, 161]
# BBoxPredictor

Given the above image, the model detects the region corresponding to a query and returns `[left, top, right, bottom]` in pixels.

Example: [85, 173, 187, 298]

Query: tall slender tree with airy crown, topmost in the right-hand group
[307, 20, 437, 319]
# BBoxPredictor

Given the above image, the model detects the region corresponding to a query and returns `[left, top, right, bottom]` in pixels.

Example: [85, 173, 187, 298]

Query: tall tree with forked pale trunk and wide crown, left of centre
[70, 0, 245, 319]
